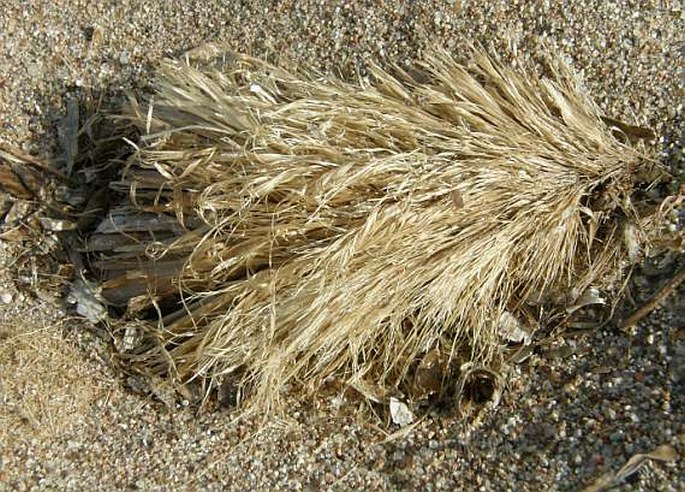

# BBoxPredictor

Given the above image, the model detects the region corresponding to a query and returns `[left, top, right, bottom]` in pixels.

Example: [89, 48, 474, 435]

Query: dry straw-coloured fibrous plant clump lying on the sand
[86, 47, 659, 412]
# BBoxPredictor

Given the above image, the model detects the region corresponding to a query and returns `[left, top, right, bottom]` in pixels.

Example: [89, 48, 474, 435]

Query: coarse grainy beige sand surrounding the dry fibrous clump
[0, 0, 685, 490]
